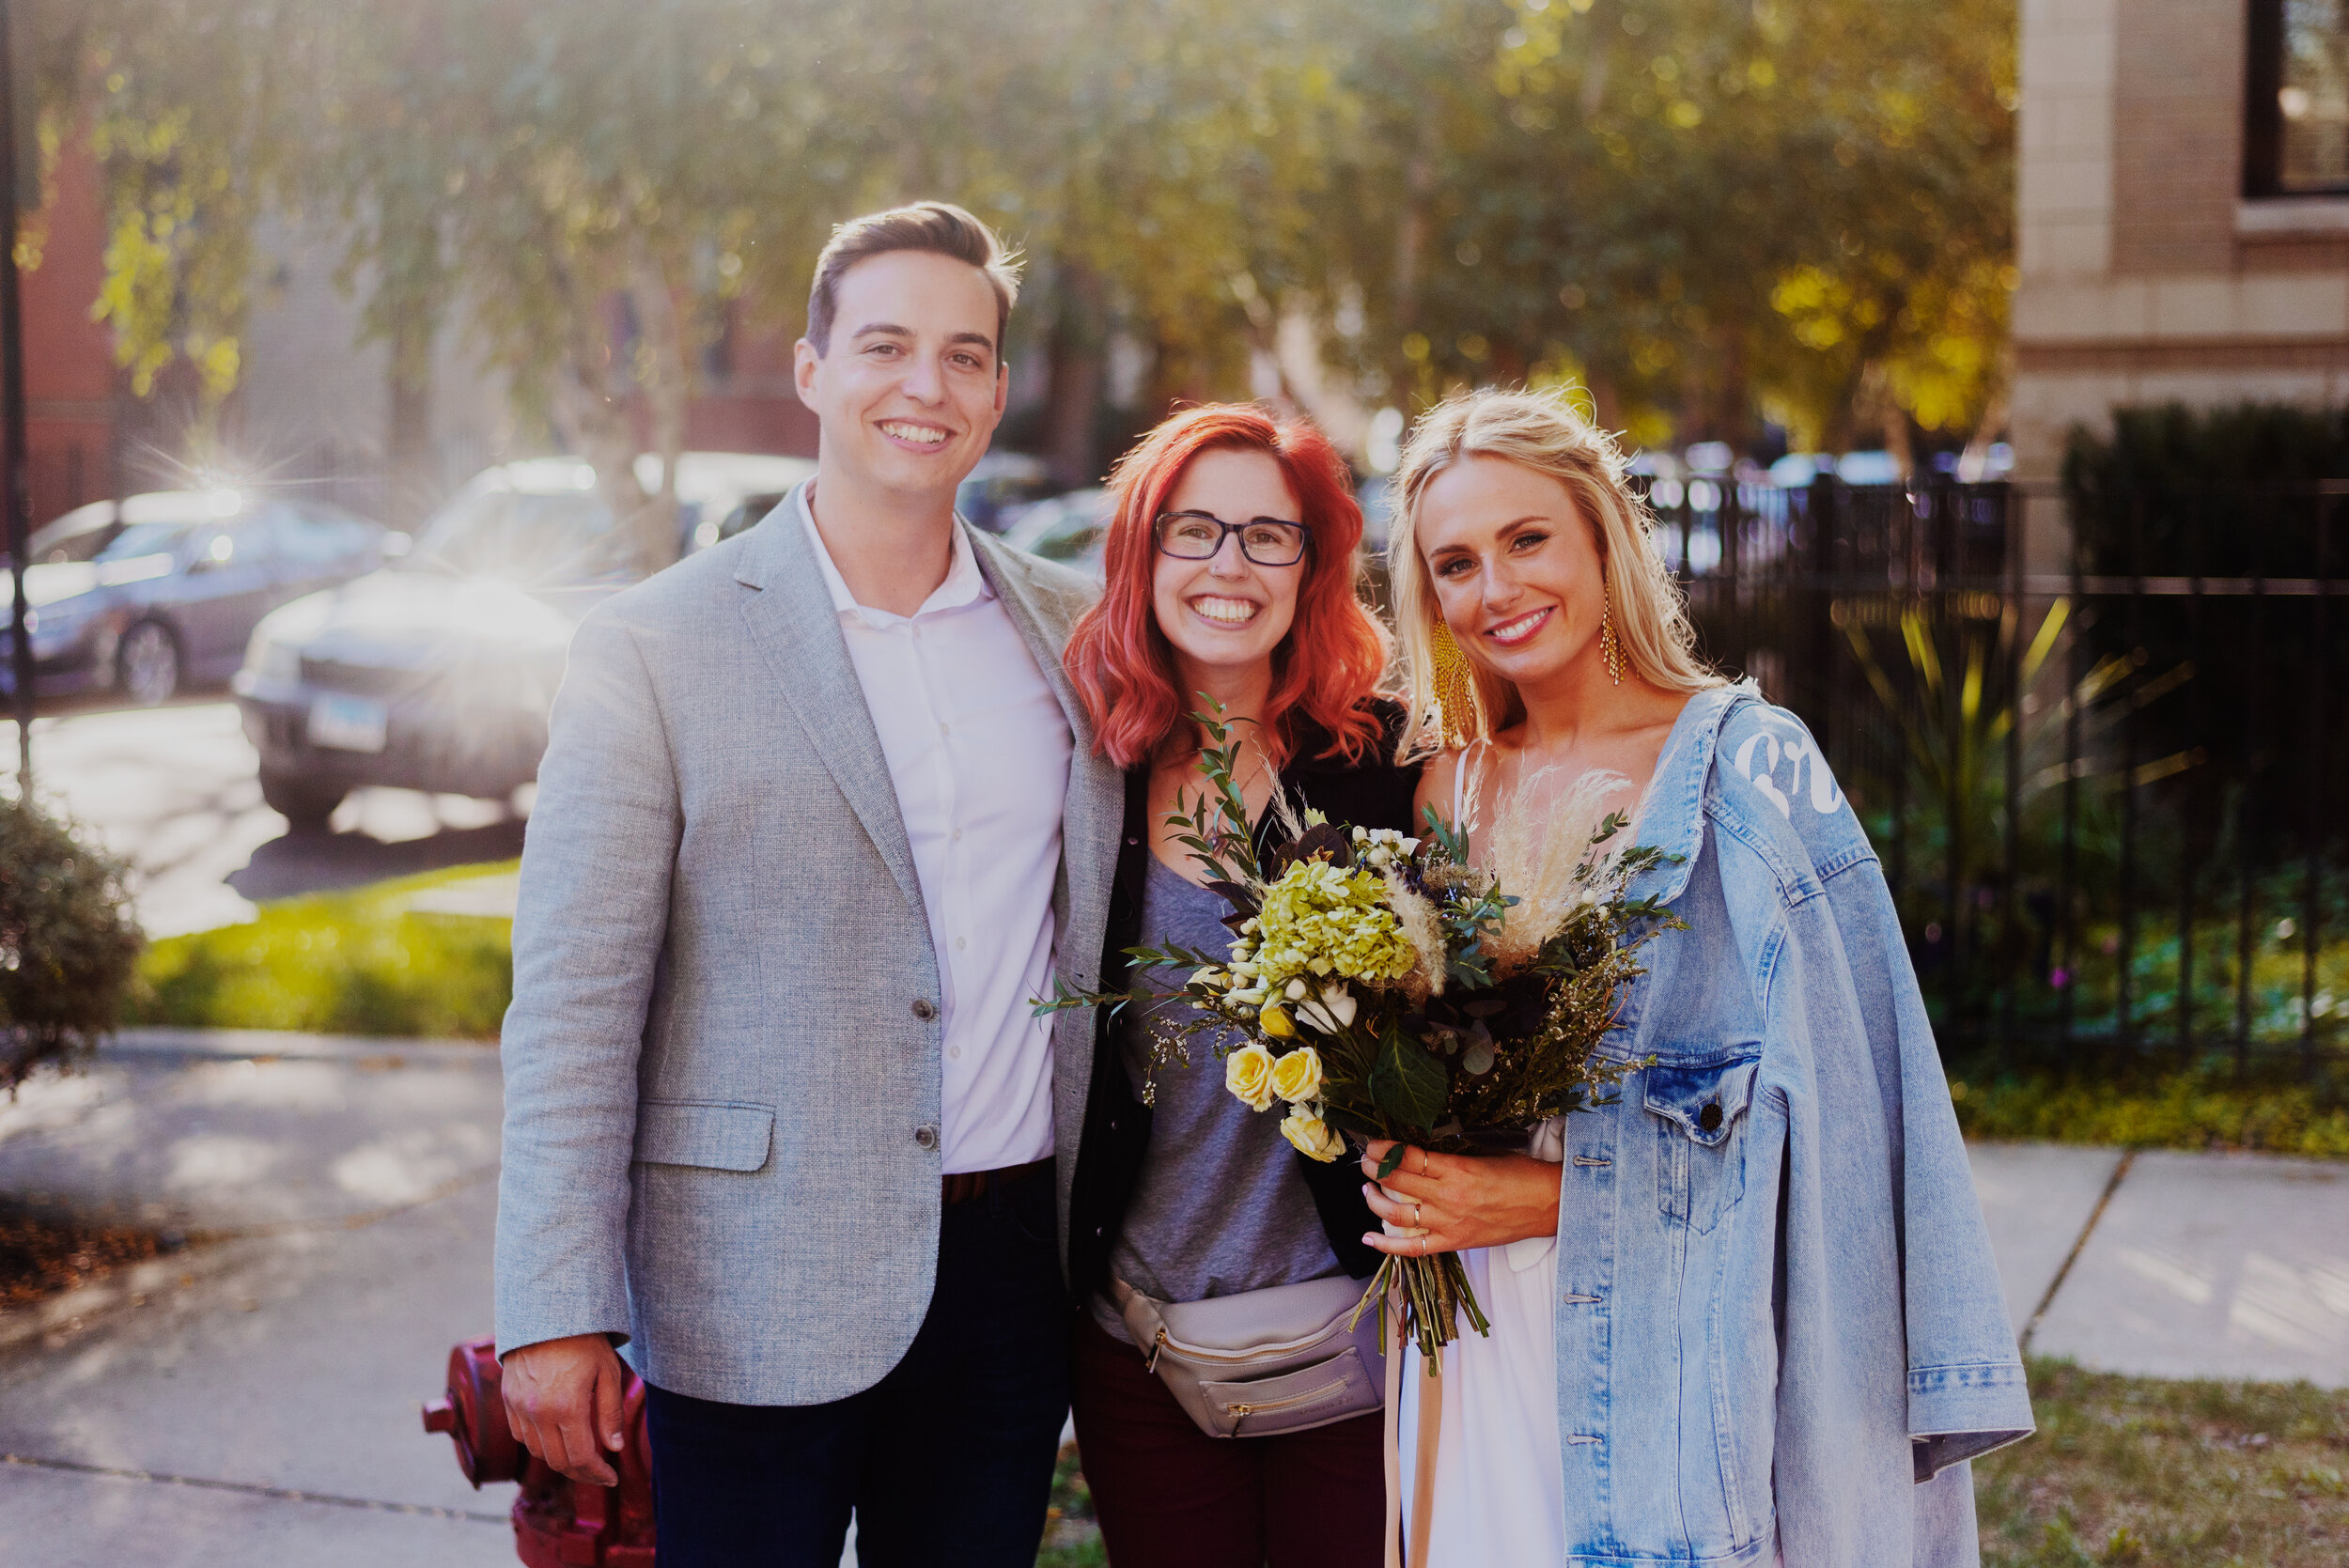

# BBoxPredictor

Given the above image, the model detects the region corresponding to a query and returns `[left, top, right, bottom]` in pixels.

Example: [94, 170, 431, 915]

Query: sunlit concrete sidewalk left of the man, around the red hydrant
[0, 1031, 515, 1568]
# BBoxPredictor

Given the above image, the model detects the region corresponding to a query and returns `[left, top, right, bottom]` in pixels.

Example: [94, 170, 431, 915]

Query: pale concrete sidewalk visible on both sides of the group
[0, 1031, 2349, 1568]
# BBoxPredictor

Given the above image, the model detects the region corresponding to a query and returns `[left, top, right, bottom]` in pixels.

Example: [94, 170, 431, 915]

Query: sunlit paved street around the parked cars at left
[0, 700, 521, 937]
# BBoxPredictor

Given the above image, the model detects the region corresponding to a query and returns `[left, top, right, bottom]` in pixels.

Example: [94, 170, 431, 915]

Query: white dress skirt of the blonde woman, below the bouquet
[1398, 1117, 1567, 1568]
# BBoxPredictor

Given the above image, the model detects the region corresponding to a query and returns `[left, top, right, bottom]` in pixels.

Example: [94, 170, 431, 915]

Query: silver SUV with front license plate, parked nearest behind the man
[233, 453, 816, 826]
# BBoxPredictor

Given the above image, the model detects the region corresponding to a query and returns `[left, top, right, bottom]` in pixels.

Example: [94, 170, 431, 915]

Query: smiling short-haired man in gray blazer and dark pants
[498, 202, 1123, 1568]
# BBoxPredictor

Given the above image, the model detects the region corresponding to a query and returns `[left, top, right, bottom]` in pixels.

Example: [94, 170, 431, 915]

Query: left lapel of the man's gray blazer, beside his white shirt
[736, 490, 926, 913]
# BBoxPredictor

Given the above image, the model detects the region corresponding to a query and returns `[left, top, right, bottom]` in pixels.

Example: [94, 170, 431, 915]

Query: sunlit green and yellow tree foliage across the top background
[45, 0, 2014, 502]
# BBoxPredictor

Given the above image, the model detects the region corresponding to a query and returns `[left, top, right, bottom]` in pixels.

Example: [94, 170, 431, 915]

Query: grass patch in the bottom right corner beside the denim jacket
[1973, 1359, 2349, 1568]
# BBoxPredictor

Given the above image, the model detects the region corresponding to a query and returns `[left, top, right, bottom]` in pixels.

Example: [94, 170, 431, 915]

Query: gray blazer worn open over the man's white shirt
[498, 505, 1123, 1404]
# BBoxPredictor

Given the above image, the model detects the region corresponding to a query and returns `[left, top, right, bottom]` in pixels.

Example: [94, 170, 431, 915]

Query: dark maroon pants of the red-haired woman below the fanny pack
[1071, 1314, 1386, 1568]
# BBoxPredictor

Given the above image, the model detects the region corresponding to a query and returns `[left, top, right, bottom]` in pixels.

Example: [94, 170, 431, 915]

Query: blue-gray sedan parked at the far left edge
[0, 490, 407, 706]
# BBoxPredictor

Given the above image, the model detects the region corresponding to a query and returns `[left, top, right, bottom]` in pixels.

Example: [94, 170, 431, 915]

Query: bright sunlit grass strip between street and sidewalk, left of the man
[125, 863, 515, 1040]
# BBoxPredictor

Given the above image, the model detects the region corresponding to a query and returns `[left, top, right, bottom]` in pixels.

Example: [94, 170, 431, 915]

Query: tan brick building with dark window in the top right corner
[2014, 0, 2349, 479]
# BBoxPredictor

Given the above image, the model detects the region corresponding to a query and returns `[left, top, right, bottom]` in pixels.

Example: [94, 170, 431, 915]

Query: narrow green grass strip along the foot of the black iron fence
[1950, 1065, 2349, 1159]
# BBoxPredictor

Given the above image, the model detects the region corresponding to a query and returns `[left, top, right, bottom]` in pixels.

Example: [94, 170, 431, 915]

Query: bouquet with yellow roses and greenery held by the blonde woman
[1041, 714, 1680, 1369]
